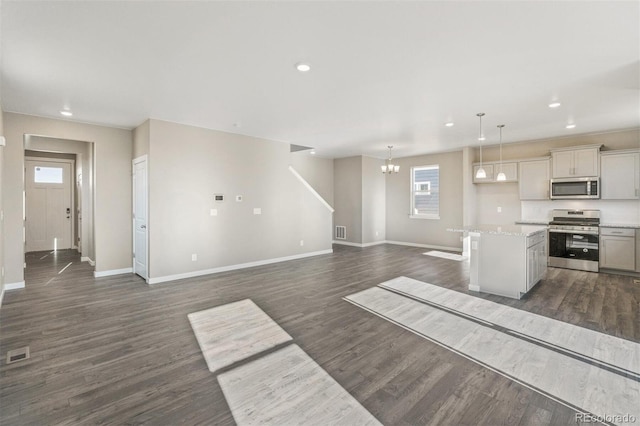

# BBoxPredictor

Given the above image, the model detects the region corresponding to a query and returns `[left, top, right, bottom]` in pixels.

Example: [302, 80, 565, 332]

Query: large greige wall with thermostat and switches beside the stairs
[146, 120, 333, 280]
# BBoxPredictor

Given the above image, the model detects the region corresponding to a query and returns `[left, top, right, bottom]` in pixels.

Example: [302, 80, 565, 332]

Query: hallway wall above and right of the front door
[24, 135, 95, 260]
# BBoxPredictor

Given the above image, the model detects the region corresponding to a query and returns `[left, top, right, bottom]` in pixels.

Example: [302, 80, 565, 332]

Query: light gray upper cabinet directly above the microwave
[551, 145, 602, 178]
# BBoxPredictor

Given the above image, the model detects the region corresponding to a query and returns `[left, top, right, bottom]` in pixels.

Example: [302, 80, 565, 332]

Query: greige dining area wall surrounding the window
[386, 151, 463, 249]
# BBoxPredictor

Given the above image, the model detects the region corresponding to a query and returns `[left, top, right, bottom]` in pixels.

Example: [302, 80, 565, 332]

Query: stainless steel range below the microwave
[549, 209, 600, 272]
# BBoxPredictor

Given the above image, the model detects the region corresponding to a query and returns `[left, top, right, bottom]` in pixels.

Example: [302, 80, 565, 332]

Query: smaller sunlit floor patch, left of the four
[187, 299, 291, 372]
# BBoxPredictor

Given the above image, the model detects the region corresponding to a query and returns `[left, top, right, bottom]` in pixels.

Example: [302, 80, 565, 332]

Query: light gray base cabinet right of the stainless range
[600, 227, 636, 271]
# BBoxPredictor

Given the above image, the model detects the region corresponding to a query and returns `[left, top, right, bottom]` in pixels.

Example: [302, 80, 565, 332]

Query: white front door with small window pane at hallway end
[25, 159, 73, 252]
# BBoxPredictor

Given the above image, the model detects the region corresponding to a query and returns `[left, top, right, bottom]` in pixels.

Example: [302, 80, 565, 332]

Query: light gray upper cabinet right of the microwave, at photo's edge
[600, 150, 640, 200]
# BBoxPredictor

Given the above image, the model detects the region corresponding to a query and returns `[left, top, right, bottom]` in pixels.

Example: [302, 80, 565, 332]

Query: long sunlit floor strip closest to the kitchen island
[379, 277, 640, 376]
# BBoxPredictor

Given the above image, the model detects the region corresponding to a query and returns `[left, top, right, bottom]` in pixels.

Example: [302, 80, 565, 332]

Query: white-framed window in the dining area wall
[411, 164, 440, 219]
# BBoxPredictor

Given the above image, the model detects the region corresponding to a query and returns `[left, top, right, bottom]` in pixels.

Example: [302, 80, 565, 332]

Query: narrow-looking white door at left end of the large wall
[133, 156, 148, 280]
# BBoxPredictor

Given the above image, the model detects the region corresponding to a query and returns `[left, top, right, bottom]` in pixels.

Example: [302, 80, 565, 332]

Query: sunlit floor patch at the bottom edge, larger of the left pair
[218, 344, 380, 426]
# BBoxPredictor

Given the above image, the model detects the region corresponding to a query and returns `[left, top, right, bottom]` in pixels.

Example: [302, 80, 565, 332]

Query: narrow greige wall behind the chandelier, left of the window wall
[362, 157, 389, 244]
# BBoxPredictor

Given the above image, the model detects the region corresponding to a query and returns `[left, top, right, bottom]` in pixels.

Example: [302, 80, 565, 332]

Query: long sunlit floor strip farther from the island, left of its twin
[345, 287, 640, 419]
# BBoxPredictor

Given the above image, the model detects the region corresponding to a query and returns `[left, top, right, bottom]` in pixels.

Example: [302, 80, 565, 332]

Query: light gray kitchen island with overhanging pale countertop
[448, 225, 547, 299]
